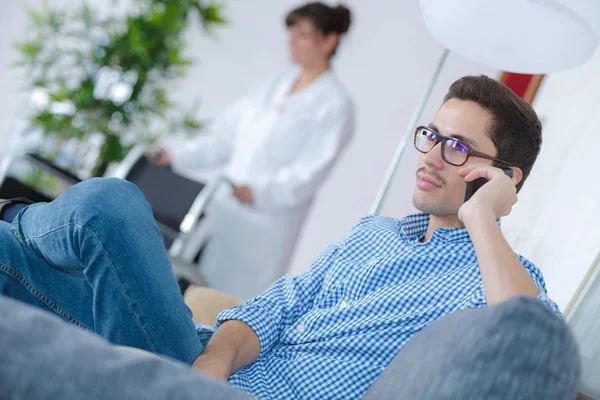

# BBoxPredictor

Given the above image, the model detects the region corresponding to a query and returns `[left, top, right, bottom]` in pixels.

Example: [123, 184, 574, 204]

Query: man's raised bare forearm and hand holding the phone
[458, 164, 540, 305]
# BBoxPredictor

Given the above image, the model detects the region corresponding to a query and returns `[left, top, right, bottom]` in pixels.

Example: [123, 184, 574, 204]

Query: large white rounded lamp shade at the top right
[420, 0, 600, 74]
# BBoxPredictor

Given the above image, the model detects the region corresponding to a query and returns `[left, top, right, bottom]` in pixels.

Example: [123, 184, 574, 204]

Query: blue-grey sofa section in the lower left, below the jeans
[0, 296, 249, 400]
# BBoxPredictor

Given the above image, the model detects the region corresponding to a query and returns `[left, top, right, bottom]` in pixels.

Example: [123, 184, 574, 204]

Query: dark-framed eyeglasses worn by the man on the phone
[415, 126, 513, 167]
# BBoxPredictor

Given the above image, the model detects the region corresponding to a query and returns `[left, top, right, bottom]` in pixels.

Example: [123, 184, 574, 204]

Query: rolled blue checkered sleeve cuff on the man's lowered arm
[215, 304, 280, 355]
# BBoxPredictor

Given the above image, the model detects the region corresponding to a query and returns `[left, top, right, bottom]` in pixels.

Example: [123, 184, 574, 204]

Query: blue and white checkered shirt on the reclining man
[209, 214, 560, 399]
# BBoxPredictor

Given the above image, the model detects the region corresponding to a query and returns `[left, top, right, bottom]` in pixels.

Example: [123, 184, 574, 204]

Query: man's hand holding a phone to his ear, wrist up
[458, 164, 517, 226]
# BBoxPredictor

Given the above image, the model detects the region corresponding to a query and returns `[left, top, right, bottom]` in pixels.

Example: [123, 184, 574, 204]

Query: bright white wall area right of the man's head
[504, 47, 600, 309]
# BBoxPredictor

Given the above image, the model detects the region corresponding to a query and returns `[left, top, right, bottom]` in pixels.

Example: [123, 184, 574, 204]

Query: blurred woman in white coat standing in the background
[152, 2, 354, 298]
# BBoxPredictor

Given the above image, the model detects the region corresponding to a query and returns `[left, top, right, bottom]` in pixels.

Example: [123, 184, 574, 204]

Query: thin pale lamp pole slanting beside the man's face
[369, 49, 450, 215]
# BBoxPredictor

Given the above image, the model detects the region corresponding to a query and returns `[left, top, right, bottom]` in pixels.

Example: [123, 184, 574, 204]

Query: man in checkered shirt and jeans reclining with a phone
[0, 76, 560, 399]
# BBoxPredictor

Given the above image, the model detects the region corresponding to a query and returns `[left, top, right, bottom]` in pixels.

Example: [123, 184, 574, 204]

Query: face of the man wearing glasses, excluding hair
[413, 99, 496, 216]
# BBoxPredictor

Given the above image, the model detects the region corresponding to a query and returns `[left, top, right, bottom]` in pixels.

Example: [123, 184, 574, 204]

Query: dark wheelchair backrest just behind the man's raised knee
[125, 157, 204, 236]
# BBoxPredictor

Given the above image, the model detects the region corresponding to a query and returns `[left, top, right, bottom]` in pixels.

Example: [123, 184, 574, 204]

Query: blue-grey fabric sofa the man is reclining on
[0, 295, 580, 400]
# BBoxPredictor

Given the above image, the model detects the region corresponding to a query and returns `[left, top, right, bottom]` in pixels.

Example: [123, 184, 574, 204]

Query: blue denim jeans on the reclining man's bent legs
[0, 179, 202, 364]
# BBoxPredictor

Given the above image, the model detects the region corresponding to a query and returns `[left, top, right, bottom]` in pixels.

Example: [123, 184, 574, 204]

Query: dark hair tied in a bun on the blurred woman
[285, 2, 352, 35]
